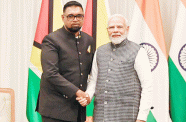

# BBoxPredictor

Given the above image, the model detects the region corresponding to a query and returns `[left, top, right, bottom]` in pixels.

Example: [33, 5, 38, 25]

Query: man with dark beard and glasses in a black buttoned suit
[36, 1, 94, 122]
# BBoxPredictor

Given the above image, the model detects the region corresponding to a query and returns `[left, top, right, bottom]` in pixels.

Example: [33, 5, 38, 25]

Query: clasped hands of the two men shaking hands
[76, 89, 91, 107]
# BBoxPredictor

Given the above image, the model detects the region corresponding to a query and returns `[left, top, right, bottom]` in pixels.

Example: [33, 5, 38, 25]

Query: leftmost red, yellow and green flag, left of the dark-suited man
[26, 0, 52, 122]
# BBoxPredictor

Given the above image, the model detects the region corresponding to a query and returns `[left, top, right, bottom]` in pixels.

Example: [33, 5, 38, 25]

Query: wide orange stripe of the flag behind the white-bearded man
[136, 0, 168, 59]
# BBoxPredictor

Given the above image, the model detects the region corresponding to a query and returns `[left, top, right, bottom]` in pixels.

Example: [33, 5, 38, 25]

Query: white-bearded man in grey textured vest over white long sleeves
[76, 14, 152, 122]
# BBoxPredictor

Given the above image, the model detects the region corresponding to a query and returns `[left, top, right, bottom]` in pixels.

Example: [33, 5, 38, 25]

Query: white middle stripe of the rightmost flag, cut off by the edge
[169, 1, 186, 81]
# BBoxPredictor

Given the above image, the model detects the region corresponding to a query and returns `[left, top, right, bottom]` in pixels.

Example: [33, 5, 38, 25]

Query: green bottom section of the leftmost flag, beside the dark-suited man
[26, 68, 42, 122]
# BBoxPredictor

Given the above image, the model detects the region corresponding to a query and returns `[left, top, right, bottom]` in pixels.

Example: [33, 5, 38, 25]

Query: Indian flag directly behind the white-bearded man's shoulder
[128, 0, 171, 122]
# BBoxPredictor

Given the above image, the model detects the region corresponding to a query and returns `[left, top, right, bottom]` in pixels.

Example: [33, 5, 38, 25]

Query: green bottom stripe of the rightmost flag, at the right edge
[169, 57, 186, 122]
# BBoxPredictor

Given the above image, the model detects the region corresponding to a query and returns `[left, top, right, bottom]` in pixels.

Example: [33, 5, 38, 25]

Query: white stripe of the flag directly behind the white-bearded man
[128, 1, 171, 122]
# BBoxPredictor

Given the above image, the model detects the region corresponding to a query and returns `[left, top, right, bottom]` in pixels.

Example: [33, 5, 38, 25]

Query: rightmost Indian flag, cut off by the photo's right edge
[169, 0, 186, 122]
